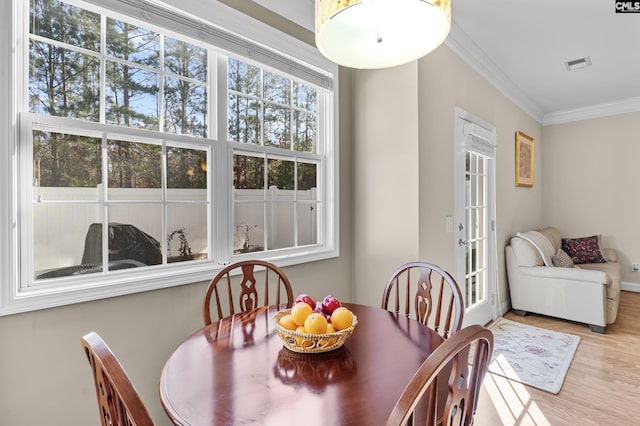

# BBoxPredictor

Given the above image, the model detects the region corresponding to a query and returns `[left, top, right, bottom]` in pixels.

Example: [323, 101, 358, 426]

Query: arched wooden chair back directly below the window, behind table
[202, 260, 294, 325]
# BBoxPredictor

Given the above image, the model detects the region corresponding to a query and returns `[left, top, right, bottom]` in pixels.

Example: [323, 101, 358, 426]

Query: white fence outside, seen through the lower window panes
[33, 187, 319, 271]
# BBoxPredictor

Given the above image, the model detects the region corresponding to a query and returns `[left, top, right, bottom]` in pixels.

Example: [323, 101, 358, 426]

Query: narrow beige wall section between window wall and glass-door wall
[353, 62, 421, 306]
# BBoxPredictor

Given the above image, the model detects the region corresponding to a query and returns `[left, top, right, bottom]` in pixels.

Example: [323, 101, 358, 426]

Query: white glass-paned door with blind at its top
[454, 109, 496, 326]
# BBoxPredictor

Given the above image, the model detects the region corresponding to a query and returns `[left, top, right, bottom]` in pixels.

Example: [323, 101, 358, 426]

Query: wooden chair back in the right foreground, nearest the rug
[387, 325, 493, 426]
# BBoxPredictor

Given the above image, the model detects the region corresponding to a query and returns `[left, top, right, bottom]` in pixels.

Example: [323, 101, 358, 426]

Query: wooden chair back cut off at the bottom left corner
[81, 331, 153, 426]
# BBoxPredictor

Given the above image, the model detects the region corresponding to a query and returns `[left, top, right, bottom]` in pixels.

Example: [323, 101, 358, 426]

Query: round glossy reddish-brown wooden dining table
[160, 303, 442, 426]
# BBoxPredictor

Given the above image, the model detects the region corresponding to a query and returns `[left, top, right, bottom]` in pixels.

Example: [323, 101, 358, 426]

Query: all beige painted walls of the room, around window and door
[0, 0, 640, 426]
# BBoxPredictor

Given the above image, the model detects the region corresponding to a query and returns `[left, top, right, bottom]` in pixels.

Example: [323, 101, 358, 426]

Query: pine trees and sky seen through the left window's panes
[29, 0, 207, 188]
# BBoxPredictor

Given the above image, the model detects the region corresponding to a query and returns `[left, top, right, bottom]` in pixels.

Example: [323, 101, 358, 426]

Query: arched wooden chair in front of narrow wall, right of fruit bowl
[381, 262, 464, 339]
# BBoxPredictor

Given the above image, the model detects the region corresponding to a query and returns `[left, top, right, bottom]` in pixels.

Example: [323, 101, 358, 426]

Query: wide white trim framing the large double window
[0, 0, 340, 316]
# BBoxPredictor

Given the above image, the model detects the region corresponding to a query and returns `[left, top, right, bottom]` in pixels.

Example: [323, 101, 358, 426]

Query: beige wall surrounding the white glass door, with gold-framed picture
[419, 45, 544, 303]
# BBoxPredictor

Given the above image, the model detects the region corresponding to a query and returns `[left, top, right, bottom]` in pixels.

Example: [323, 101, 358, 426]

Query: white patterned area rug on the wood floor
[489, 318, 580, 394]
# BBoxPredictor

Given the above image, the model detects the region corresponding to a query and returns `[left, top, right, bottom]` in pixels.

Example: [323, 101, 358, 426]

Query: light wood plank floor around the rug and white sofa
[475, 291, 640, 426]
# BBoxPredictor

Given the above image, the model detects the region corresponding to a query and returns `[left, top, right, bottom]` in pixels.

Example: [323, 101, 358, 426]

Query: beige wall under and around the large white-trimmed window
[0, 4, 353, 426]
